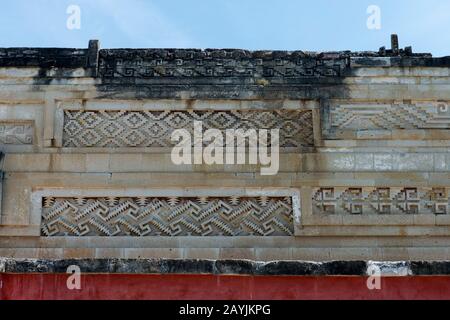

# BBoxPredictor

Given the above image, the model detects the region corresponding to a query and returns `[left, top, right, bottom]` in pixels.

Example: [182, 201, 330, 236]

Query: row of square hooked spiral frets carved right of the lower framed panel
[312, 187, 450, 215]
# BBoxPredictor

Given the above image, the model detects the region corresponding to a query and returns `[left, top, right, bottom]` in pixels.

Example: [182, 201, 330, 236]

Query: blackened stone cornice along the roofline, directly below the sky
[0, 45, 444, 81]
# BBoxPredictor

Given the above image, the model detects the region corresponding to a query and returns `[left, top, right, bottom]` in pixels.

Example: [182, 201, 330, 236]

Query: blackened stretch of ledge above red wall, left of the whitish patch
[0, 258, 366, 275]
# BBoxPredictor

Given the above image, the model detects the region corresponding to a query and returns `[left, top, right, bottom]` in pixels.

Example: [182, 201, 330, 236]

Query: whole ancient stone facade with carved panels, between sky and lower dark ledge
[0, 41, 450, 261]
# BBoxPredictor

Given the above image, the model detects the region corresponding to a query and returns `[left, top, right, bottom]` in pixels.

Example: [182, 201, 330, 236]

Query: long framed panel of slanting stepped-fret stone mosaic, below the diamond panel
[41, 196, 294, 236]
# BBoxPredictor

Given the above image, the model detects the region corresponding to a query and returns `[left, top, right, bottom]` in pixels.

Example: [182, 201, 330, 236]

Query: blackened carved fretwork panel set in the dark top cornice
[99, 49, 350, 79]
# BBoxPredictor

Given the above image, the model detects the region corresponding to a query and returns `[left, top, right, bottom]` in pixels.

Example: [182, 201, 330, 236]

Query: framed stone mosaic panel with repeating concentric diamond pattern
[63, 110, 314, 148]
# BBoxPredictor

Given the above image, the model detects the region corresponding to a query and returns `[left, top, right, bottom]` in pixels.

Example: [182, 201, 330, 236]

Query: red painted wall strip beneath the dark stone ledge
[0, 274, 450, 300]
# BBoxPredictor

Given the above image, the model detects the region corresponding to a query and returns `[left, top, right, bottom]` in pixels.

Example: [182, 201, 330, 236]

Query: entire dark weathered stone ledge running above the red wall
[0, 258, 450, 276]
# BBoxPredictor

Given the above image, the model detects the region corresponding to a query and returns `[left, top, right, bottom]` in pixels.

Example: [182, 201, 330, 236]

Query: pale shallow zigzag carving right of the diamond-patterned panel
[330, 102, 450, 130]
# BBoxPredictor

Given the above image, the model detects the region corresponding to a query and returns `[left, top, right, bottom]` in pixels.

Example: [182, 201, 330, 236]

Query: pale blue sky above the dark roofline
[0, 0, 450, 56]
